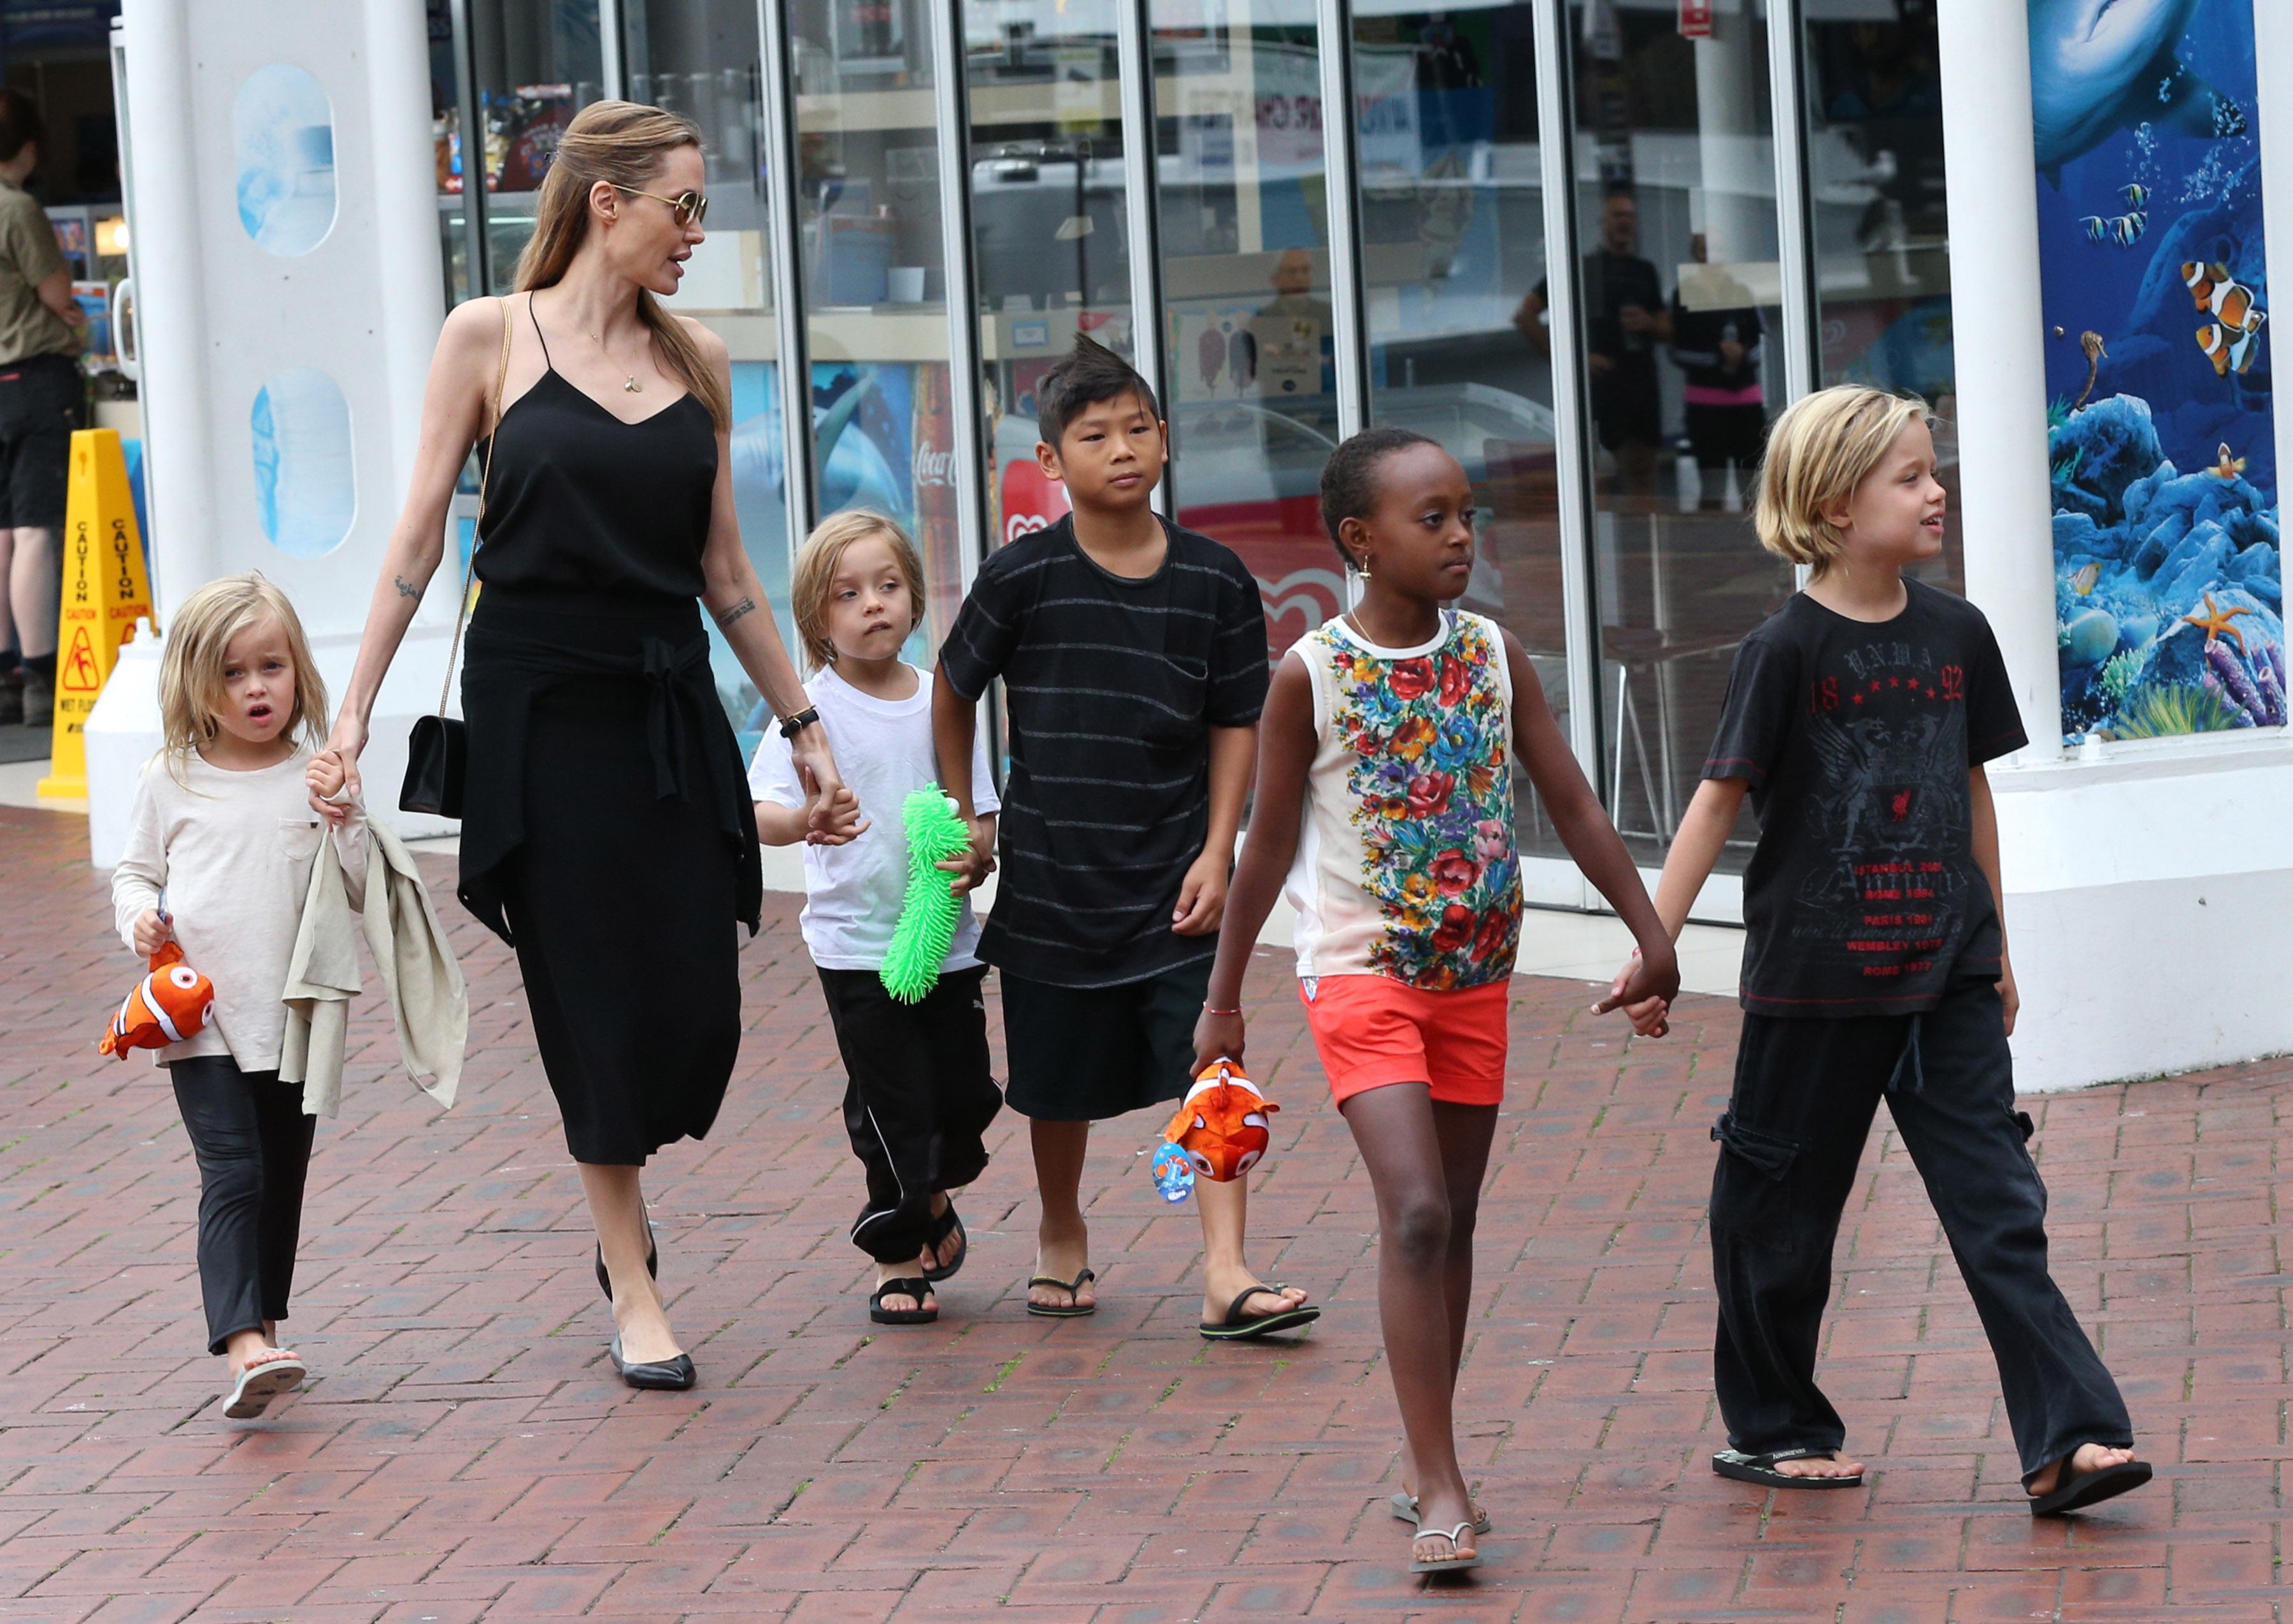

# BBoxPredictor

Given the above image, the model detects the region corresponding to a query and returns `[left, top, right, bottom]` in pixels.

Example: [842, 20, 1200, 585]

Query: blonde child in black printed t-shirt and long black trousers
[1617, 388, 2151, 1516]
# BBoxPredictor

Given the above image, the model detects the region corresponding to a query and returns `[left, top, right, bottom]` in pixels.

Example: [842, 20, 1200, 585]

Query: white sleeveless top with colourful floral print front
[1284, 610, 1520, 991]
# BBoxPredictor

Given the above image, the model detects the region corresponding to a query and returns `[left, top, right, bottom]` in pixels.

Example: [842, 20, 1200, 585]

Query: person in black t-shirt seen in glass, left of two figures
[1513, 188, 1671, 495]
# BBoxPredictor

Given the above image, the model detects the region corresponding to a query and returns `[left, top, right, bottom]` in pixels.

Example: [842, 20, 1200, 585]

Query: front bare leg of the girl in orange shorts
[1339, 1083, 1495, 1562]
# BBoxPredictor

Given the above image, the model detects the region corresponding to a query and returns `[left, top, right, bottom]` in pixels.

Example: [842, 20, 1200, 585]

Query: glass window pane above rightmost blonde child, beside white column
[1804, 0, 1965, 592]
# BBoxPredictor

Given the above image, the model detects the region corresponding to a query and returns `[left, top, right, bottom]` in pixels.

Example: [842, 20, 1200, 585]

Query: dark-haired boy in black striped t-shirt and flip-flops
[931, 335, 1321, 1337]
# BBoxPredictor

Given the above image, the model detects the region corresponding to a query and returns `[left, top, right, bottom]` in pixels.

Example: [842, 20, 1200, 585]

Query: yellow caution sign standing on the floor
[39, 429, 156, 801]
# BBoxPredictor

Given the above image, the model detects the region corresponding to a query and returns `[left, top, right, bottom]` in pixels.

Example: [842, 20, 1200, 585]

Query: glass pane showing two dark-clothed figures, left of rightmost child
[1559, 0, 1793, 890]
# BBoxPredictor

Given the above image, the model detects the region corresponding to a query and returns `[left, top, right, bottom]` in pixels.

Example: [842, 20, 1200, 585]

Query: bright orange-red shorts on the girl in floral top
[1298, 975, 1511, 1106]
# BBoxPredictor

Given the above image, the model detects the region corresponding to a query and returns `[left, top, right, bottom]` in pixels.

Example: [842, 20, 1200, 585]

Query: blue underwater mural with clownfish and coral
[2029, 0, 2286, 743]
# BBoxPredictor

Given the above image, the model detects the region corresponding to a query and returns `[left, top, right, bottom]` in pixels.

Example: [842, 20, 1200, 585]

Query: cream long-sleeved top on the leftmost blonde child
[112, 750, 367, 1071]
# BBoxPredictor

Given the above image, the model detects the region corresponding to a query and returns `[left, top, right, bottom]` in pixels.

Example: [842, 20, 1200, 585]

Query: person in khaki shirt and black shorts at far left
[0, 89, 87, 727]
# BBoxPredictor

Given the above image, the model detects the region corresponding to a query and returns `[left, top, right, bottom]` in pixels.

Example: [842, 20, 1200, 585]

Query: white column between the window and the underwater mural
[1935, 0, 2061, 759]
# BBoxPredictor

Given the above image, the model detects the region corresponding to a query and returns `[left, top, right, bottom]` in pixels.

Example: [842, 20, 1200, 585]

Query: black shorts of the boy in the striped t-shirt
[1002, 958, 1215, 1122]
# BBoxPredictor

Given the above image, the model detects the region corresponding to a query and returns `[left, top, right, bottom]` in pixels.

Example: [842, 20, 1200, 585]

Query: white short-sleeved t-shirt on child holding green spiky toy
[748, 667, 1002, 971]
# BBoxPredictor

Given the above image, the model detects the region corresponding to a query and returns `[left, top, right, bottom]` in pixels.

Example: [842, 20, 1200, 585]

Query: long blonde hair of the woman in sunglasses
[518, 101, 731, 429]
